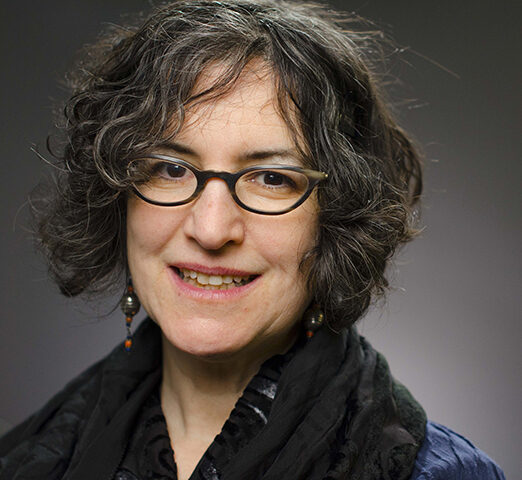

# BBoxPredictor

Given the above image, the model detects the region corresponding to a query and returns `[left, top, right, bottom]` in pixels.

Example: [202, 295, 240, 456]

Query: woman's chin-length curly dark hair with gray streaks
[36, 0, 422, 329]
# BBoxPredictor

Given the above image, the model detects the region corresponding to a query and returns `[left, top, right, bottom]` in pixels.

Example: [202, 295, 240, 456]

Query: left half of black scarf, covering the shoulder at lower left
[0, 321, 161, 480]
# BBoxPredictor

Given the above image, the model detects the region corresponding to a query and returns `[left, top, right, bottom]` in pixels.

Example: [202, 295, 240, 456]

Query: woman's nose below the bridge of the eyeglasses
[184, 178, 245, 250]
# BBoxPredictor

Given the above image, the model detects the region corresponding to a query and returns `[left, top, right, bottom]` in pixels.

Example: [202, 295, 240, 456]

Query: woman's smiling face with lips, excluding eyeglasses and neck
[127, 65, 318, 359]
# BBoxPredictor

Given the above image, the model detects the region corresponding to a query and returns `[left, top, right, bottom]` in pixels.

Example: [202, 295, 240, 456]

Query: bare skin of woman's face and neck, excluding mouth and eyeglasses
[127, 64, 318, 479]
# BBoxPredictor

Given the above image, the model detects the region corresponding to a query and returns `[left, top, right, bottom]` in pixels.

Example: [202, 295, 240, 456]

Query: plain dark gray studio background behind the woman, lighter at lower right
[0, 0, 522, 478]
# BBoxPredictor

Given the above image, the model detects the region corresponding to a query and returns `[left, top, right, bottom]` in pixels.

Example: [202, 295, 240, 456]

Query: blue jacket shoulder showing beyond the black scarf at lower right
[411, 421, 505, 480]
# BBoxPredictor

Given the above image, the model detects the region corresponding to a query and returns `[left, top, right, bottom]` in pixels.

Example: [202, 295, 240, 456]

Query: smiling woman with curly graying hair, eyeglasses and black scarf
[0, 1, 503, 480]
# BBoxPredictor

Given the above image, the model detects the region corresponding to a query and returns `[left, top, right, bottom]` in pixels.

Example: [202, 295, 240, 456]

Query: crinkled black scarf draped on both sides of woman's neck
[0, 321, 426, 480]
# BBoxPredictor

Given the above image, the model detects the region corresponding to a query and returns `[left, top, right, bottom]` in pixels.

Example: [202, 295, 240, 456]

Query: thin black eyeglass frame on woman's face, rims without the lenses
[129, 154, 328, 215]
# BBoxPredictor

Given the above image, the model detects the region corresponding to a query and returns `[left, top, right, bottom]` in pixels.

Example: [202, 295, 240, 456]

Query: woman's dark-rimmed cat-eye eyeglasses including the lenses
[127, 154, 328, 215]
